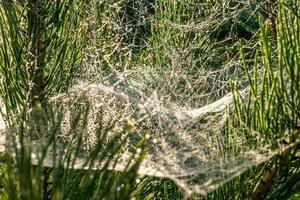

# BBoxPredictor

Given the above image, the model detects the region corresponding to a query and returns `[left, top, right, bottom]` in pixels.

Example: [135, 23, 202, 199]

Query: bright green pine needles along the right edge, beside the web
[207, 1, 300, 199]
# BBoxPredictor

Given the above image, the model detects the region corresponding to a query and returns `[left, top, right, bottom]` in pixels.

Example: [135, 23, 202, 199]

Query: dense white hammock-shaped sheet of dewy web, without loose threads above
[46, 71, 280, 194]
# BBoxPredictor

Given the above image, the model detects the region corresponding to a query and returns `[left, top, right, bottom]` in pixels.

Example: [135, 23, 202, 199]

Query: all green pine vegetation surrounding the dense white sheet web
[0, 0, 300, 200]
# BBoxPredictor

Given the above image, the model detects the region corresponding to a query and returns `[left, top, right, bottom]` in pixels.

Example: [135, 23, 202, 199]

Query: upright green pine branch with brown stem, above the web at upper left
[0, 0, 85, 110]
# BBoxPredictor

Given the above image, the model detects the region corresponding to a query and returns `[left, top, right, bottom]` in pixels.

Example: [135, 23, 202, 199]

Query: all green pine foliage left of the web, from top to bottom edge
[0, 0, 144, 199]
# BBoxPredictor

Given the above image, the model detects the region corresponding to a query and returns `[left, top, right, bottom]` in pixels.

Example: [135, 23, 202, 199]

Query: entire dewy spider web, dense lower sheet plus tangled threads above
[0, 0, 290, 194]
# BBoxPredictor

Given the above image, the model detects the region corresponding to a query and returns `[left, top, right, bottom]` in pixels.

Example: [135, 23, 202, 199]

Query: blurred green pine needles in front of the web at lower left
[1, 100, 145, 199]
